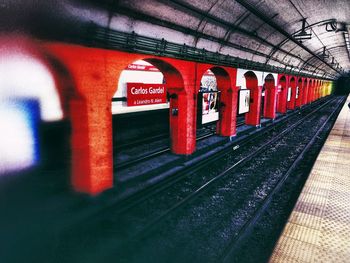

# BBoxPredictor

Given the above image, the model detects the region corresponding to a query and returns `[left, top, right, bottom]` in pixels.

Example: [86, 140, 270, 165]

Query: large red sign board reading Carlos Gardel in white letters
[126, 83, 166, 106]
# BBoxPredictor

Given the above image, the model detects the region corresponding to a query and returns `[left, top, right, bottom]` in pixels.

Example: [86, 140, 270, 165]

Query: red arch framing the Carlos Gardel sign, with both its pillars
[47, 43, 205, 194]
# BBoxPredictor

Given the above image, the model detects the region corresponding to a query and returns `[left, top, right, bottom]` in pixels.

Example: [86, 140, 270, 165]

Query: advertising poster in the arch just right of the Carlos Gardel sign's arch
[202, 92, 219, 124]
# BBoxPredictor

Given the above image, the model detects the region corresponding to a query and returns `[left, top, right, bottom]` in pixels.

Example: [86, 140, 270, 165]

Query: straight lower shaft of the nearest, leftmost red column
[70, 98, 113, 194]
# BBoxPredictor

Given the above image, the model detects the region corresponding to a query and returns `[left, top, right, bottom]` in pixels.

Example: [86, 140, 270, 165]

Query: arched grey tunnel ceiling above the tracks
[0, 0, 350, 79]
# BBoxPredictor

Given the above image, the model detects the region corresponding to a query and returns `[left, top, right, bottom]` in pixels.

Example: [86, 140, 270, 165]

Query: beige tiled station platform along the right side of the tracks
[270, 96, 350, 263]
